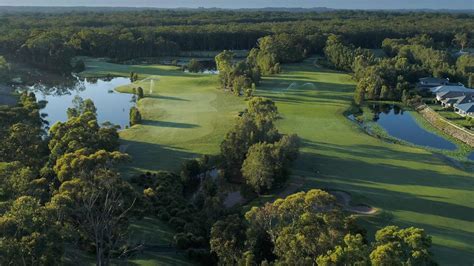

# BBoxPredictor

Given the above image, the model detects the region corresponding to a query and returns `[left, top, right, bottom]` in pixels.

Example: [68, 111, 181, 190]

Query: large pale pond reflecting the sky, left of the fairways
[28, 77, 135, 129]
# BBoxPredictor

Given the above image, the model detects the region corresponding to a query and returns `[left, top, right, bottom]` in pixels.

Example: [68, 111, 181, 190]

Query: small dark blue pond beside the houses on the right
[369, 104, 457, 150]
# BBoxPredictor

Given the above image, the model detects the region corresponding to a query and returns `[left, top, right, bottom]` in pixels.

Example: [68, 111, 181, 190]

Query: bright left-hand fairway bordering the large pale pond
[82, 57, 245, 175]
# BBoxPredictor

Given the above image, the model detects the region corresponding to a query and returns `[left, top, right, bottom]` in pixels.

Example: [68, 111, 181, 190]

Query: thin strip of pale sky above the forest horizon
[0, 0, 474, 10]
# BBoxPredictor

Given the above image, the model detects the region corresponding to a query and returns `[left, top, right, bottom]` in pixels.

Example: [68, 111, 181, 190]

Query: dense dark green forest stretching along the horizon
[0, 10, 474, 72]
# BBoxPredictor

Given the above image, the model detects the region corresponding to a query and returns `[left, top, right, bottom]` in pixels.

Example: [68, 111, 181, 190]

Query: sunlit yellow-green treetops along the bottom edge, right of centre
[210, 189, 435, 265]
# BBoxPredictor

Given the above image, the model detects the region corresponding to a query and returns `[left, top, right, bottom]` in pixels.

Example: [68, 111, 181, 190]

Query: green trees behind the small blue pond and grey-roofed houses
[324, 34, 474, 104]
